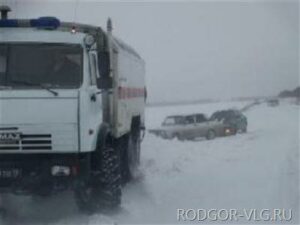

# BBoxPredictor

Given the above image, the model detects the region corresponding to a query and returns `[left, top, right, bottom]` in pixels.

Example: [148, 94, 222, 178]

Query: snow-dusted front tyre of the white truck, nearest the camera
[75, 147, 122, 214]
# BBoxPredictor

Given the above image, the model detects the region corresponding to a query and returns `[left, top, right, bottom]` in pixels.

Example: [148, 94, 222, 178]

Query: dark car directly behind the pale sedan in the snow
[210, 109, 248, 133]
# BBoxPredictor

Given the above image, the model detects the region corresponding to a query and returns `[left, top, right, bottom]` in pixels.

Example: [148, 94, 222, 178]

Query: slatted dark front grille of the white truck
[0, 134, 52, 150]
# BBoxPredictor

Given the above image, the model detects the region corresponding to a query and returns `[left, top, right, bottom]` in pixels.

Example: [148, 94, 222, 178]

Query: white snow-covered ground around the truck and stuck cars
[0, 102, 300, 225]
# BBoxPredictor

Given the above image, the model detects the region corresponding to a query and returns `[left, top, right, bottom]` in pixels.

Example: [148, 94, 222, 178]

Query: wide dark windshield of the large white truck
[0, 43, 83, 88]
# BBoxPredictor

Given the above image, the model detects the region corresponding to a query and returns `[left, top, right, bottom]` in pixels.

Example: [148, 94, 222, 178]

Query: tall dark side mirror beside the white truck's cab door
[97, 51, 113, 89]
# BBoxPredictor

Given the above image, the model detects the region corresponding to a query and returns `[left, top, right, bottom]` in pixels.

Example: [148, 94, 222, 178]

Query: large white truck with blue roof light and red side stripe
[0, 7, 146, 212]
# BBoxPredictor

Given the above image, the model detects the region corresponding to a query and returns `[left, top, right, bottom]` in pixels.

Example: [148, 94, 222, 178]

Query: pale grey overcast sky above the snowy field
[0, 0, 299, 102]
